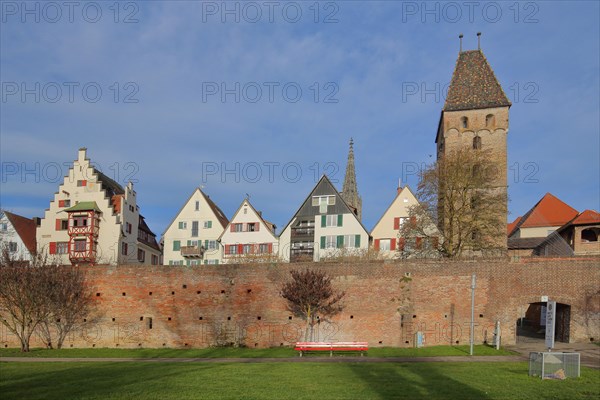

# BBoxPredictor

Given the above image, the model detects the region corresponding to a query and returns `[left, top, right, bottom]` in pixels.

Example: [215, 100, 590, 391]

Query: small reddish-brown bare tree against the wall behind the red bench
[280, 269, 346, 340]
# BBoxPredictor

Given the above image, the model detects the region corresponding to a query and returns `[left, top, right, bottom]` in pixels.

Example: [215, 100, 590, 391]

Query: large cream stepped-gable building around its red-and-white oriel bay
[36, 148, 161, 265]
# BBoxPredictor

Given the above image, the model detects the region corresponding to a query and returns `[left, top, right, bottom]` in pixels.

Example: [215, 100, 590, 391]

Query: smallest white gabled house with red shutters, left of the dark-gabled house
[219, 199, 279, 263]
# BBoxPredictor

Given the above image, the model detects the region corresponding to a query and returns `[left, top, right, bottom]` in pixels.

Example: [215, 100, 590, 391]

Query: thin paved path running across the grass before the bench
[0, 356, 523, 364]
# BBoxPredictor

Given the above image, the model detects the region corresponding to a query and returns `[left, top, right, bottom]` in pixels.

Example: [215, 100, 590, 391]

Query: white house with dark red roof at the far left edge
[0, 210, 37, 262]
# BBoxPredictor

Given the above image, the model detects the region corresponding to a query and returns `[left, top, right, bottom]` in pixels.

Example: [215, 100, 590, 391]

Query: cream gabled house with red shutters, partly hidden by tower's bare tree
[371, 186, 438, 259]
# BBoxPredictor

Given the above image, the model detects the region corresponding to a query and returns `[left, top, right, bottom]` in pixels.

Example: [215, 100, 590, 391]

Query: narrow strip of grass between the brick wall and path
[0, 345, 516, 358]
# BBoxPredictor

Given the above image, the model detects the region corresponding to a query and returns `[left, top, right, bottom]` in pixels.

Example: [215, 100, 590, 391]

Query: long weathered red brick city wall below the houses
[0, 259, 600, 348]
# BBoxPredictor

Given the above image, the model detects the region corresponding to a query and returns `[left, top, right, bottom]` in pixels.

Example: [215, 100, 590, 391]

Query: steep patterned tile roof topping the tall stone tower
[444, 50, 511, 111]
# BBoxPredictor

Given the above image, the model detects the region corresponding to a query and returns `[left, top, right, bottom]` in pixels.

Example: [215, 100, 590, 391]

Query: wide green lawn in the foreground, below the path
[0, 362, 600, 400]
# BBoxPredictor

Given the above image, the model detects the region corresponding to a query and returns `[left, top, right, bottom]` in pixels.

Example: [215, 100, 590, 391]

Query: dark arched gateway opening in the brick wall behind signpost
[516, 302, 571, 343]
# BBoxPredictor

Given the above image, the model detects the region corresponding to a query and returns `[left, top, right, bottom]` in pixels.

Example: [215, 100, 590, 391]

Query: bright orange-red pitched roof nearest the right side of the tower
[508, 193, 578, 236]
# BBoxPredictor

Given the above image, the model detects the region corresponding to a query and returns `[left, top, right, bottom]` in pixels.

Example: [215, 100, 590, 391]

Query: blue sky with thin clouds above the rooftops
[0, 1, 600, 236]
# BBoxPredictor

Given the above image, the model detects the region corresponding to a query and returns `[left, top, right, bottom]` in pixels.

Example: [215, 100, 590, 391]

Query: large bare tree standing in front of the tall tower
[400, 149, 507, 258]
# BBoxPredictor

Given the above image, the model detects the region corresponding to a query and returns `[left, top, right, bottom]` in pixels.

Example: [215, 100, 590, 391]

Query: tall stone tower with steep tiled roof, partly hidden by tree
[435, 33, 511, 251]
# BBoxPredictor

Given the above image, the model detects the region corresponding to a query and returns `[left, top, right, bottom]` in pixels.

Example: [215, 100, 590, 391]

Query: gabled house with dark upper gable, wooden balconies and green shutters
[279, 175, 369, 262]
